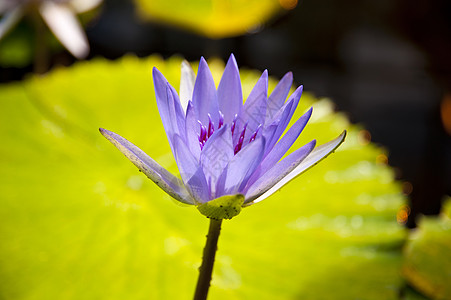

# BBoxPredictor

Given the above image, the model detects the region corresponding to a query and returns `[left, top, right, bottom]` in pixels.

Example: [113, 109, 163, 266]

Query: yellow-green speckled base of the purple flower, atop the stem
[197, 194, 244, 220]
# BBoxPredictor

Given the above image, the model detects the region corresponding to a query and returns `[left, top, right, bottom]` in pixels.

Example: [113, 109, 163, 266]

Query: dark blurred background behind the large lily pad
[0, 0, 451, 227]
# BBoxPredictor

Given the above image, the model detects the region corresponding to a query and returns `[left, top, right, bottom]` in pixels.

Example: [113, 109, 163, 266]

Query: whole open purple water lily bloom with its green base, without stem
[100, 55, 346, 219]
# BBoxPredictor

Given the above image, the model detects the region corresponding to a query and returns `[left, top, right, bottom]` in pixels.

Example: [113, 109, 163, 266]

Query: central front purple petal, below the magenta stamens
[200, 124, 234, 198]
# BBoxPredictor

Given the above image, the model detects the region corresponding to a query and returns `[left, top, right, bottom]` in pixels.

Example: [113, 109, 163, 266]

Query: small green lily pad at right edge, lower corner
[403, 199, 451, 299]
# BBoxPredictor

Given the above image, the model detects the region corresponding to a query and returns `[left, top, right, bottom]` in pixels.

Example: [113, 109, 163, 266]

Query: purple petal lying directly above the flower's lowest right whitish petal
[245, 140, 316, 203]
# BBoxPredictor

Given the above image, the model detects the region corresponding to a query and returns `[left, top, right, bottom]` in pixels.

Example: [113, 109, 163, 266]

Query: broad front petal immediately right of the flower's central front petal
[216, 138, 265, 197]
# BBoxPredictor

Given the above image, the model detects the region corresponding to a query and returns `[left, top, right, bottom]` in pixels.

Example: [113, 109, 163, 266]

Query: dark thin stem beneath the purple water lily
[194, 219, 222, 300]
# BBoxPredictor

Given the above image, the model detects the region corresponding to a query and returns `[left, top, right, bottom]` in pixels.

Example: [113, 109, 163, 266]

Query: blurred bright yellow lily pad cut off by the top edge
[135, 0, 288, 38]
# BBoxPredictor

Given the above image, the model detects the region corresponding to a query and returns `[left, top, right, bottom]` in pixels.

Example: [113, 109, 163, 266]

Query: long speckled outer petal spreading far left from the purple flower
[100, 128, 194, 204]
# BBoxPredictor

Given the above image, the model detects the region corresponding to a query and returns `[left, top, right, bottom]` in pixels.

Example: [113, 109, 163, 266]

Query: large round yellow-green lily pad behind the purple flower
[0, 56, 413, 300]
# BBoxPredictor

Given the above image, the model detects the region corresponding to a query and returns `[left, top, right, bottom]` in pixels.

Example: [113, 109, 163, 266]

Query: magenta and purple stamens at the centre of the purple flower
[197, 112, 262, 154]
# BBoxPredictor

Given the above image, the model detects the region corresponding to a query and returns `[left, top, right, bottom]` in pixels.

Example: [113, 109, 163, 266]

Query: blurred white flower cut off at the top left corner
[0, 0, 102, 59]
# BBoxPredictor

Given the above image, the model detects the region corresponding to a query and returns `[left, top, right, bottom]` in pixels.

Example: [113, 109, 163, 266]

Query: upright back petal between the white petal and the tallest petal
[193, 57, 219, 125]
